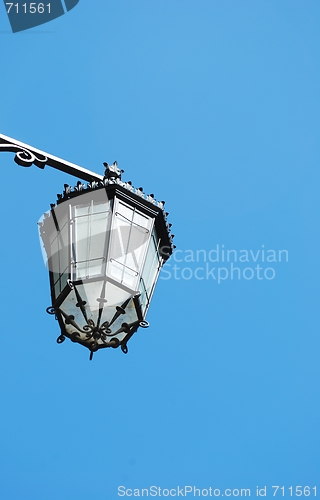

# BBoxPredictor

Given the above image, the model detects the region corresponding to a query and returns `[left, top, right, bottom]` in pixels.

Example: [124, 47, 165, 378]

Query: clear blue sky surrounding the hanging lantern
[0, 0, 320, 500]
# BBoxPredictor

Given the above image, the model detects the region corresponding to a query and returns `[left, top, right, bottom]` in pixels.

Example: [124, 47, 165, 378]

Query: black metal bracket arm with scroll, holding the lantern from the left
[0, 134, 103, 182]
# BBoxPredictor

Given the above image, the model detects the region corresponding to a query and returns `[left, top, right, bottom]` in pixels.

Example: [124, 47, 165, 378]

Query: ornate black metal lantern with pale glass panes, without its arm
[39, 162, 174, 359]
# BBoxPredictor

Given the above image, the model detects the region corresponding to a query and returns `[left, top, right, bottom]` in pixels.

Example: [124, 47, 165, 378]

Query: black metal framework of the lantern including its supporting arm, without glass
[0, 134, 175, 359]
